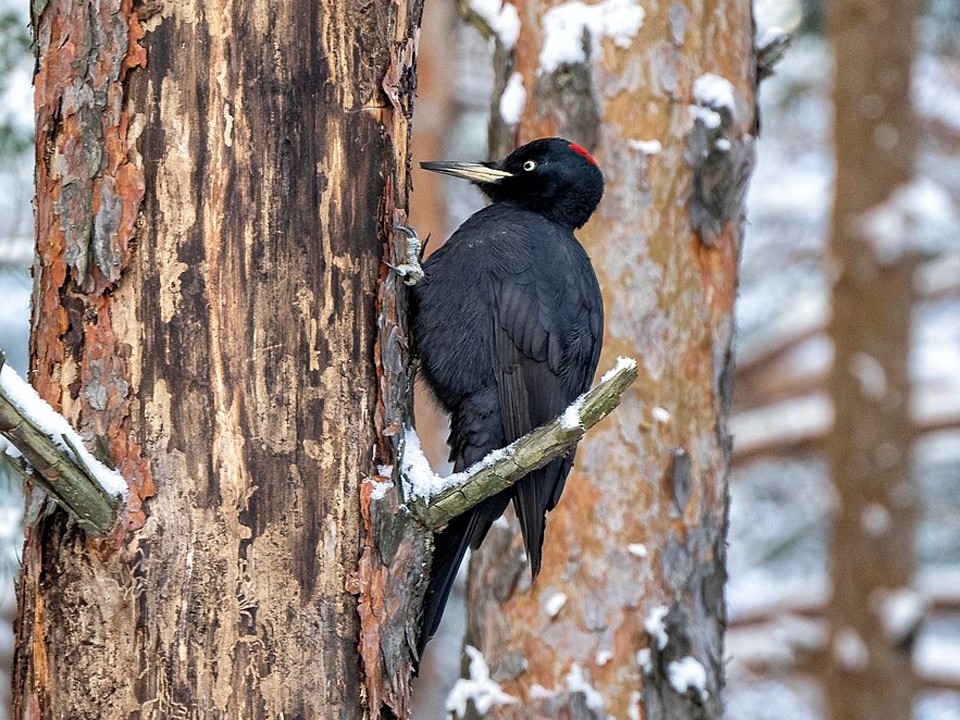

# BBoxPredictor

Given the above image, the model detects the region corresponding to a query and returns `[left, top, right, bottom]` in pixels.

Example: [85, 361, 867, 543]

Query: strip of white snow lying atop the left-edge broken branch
[0, 364, 129, 500]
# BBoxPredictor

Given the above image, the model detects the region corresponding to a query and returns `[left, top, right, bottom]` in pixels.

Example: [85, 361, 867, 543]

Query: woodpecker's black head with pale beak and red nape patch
[420, 138, 603, 228]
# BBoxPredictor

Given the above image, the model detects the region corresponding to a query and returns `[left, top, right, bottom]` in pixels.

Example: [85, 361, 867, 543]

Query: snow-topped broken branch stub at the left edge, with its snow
[0, 352, 128, 535]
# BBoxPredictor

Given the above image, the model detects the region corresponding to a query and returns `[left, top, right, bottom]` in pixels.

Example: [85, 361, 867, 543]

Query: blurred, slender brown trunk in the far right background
[826, 0, 920, 720]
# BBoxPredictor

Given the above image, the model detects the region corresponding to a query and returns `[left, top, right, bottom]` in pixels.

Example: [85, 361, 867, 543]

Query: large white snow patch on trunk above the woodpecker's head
[537, 0, 644, 74]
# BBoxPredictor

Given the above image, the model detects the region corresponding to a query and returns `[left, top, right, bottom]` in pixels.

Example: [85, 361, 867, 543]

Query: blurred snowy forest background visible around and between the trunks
[0, 0, 960, 720]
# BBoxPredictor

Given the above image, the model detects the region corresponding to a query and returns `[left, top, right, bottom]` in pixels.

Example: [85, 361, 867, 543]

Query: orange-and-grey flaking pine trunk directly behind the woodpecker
[467, 0, 756, 719]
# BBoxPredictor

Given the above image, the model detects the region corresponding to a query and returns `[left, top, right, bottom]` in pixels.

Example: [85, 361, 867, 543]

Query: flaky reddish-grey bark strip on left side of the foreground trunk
[30, 0, 153, 533]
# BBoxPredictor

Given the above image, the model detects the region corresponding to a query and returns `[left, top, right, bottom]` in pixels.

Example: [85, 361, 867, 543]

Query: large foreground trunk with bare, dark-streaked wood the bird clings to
[15, 0, 420, 720]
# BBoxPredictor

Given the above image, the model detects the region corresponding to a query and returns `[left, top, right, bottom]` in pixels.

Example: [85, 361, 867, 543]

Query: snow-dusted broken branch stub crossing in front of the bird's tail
[400, 357, 637, 530]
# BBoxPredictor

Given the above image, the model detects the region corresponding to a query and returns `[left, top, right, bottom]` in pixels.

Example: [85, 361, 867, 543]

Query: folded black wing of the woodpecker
[493, 222, 603, 575]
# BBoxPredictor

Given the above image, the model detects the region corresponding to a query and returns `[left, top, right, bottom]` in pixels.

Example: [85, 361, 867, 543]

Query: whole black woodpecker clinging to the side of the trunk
[412, 138, 603, 652]
